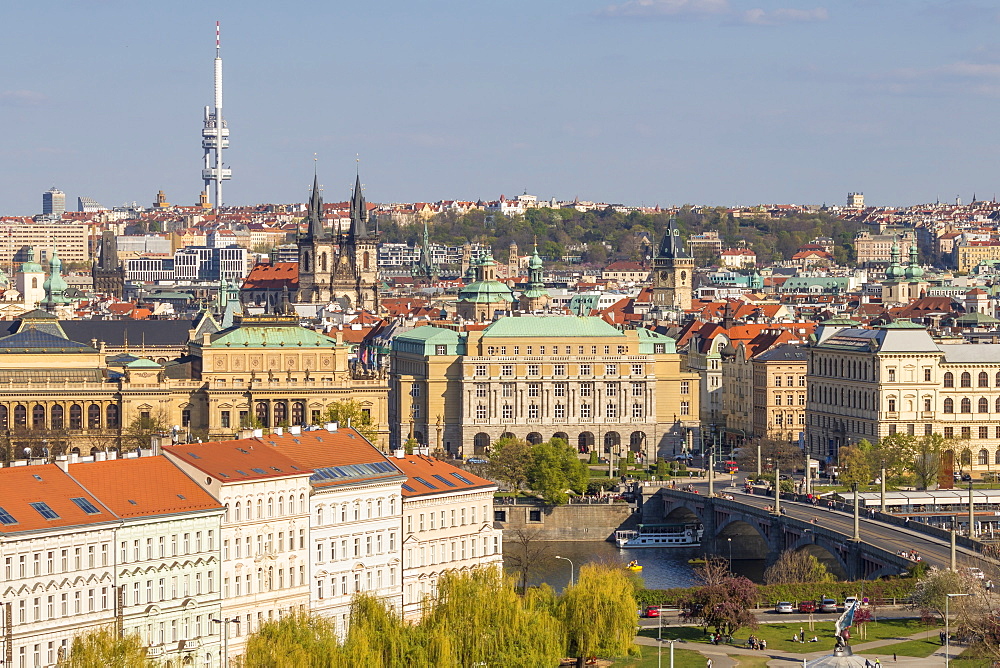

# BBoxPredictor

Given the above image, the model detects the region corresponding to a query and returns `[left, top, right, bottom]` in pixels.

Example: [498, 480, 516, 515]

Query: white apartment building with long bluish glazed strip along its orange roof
[263, 423, 405, 633]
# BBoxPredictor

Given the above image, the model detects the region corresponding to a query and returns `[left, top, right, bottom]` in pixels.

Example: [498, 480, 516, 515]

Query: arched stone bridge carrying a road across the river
[642, 489, 913, 580]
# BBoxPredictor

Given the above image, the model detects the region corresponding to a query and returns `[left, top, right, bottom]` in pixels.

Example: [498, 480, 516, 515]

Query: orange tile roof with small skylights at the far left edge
[0, 464, 116, 535]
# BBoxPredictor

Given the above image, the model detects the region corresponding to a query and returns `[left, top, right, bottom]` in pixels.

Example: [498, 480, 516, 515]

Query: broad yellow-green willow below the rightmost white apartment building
[420, 568, 564, 668]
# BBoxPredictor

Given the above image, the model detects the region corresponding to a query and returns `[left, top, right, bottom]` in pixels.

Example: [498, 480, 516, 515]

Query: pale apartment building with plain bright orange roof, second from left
[69, 453, 224, 666]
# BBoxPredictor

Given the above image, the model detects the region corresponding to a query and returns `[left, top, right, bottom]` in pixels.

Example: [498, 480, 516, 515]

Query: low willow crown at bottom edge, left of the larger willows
[243, 613, 346, 668]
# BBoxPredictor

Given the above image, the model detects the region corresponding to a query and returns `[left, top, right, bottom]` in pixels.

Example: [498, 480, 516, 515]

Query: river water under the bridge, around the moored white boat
[505, 541, 764, 591]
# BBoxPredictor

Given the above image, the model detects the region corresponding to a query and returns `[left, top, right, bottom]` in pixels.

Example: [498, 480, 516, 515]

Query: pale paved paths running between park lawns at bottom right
[635, 631, 965, 668]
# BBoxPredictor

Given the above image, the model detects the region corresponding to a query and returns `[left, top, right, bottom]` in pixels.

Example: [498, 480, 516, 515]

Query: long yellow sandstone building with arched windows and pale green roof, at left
[0, 311, 388, 457]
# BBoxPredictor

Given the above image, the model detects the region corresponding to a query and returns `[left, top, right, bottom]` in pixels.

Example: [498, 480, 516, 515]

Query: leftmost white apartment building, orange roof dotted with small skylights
[0, 462, 120, 668]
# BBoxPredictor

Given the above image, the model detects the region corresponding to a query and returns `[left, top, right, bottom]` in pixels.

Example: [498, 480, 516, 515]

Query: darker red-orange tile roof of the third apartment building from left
[163, 438, 312, 484]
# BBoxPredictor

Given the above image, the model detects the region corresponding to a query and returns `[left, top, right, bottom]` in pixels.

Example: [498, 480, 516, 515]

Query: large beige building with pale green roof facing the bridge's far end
[389, 315, 698, 457]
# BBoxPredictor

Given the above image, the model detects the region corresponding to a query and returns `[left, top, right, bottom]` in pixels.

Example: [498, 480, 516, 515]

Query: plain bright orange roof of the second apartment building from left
[69, 457, 222, 517]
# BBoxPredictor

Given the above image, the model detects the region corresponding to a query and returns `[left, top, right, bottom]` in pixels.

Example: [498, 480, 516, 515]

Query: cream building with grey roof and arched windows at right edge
[806, 322, 1000, 472]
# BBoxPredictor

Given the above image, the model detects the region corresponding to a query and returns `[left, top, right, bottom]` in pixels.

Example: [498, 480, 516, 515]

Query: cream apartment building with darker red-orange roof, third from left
[163, 437, 312, 658]
